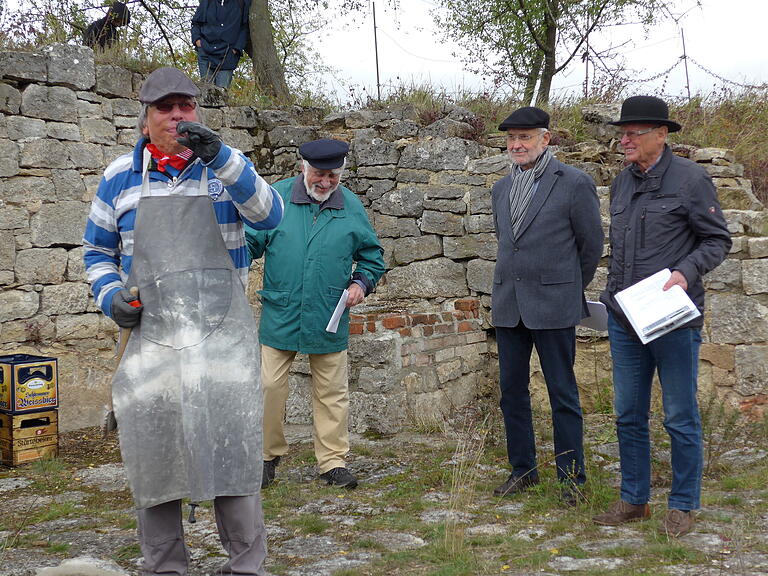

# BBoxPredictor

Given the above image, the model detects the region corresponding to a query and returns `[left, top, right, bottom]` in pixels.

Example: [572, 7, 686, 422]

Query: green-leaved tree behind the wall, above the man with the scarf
[434, 0, 669, 104]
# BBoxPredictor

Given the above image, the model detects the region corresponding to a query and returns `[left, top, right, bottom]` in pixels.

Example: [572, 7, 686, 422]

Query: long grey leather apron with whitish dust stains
[112, 162, 263, 508]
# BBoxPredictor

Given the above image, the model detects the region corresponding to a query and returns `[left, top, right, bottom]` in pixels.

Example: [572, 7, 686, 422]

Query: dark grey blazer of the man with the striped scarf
[491, 158, 603, 330]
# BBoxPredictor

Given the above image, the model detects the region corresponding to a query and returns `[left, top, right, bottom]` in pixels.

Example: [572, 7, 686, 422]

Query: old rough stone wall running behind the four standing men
[0, 46, 768, 433]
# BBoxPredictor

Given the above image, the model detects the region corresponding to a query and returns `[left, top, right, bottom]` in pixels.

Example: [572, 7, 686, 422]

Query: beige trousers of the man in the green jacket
[261, 344, 349, 474]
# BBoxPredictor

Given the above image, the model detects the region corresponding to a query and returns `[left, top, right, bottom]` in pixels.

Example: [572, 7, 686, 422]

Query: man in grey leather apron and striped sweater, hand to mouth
[83, 68, 283, 576]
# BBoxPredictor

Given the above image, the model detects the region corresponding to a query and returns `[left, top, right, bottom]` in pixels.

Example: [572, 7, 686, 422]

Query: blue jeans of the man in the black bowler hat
[608, 315, 704, 510]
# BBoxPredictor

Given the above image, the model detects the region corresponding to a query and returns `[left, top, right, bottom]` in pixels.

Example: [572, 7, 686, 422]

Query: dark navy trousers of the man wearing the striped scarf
[496, 322, 587, 484]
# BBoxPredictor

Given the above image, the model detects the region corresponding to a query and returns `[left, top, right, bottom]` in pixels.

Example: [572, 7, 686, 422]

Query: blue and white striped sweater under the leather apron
[83, 138, 283, 316]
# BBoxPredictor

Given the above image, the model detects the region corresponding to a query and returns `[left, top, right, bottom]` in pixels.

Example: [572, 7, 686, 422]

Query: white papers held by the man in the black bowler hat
[616, 268, 701, 344]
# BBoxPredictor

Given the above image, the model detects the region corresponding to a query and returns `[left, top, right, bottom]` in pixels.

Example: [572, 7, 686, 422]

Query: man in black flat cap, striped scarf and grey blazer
[491, 107, 603, 504]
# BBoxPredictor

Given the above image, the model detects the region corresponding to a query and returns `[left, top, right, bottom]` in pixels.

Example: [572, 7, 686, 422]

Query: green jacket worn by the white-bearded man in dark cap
[246, 176, 384, 354]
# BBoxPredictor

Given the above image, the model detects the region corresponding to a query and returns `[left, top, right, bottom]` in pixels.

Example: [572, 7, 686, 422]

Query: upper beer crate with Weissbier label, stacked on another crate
[0, 354, 59, 414]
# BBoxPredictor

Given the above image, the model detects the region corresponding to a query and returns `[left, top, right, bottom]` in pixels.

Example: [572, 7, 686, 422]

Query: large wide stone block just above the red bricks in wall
[386, 258, 469, 298]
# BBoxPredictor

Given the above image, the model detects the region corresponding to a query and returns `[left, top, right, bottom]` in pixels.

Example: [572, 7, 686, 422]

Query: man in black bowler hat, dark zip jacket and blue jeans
[594, 96, 731, 537]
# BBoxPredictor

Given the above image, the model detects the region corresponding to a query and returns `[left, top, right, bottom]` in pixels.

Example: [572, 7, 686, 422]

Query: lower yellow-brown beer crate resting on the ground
[0, 410, 59, 466]
